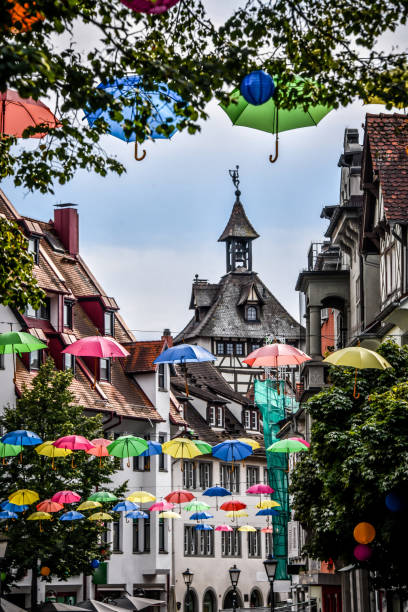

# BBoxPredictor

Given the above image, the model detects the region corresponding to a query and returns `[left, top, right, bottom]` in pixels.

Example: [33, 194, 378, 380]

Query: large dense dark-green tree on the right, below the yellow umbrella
[291, 341, 408, 589]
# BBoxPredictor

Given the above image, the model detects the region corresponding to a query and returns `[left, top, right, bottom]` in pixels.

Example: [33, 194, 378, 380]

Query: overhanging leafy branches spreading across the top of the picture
[0, 0, 408, 193]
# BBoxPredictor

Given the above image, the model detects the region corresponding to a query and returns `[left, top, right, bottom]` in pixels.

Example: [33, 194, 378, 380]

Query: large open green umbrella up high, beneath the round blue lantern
[220, 78, 333, 163]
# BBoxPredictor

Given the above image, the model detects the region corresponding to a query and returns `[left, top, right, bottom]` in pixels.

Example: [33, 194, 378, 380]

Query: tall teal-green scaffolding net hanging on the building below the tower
[255, 380, 299, 580]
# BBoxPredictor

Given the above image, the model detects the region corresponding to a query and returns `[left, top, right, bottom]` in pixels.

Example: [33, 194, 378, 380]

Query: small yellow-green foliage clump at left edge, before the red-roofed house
[0, 217, 45, 312]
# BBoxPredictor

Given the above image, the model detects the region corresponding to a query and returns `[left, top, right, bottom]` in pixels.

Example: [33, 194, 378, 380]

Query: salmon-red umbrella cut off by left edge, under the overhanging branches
[0, 89, 60, 138]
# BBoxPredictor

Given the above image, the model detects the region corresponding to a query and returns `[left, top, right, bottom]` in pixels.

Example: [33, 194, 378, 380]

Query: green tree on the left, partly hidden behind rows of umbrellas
[0, 359, 126, 604]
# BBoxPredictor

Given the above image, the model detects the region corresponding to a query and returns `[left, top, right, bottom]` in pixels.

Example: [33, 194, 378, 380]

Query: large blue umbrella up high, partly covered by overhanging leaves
[84, 75, 183, 161]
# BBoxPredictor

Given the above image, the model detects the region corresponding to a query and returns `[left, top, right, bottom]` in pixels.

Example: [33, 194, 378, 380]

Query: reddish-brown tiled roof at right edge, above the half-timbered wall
[364, 113, 408, 222]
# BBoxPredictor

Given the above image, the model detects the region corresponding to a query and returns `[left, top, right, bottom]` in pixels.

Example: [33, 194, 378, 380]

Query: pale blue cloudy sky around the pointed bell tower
[1, 0, 404, 339]
